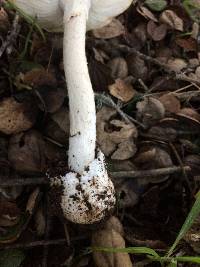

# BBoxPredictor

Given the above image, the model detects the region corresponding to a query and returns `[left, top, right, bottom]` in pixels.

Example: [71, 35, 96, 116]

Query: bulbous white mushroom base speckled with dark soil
[51, 151, 116, 224]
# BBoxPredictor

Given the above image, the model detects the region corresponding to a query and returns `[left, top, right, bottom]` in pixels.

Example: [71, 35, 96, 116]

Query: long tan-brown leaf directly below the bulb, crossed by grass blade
[92, 218, 133, 267]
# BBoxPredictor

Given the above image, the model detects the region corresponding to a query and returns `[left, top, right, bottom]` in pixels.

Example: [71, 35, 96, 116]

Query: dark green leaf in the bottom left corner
[0, 249, 25, 267]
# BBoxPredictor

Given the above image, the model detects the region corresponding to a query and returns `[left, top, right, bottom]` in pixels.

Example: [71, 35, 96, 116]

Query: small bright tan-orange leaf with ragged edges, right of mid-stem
[108, 79, 136, 102]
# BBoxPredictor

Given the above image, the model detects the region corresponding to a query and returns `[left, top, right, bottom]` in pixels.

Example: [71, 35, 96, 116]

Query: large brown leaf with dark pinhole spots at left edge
[0, 97, 37, 134]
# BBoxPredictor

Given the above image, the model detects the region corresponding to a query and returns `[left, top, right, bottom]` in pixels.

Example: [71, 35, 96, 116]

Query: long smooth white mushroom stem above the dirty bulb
[63, 0, 96, 174]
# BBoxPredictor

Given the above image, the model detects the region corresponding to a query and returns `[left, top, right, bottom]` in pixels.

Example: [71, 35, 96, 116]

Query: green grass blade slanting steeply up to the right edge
[166, 192, 200, 257]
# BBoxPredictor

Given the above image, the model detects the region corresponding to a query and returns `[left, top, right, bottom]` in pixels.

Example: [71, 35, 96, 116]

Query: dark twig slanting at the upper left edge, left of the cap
[0, 14, 20, 57]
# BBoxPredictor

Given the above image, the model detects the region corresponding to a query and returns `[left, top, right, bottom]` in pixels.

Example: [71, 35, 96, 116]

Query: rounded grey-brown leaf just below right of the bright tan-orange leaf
[136, 97, 165, 127]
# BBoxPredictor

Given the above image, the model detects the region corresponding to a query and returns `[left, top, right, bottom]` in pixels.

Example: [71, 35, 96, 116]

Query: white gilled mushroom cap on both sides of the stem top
[12, 0, 133, 32]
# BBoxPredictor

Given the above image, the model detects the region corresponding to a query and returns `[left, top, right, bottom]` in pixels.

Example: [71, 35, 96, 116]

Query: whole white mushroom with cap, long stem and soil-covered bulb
[10, 0, 132, 224]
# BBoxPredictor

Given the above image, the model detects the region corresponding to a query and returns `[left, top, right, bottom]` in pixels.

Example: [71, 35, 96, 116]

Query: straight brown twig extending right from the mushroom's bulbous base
[110, 166, 191, 179]
